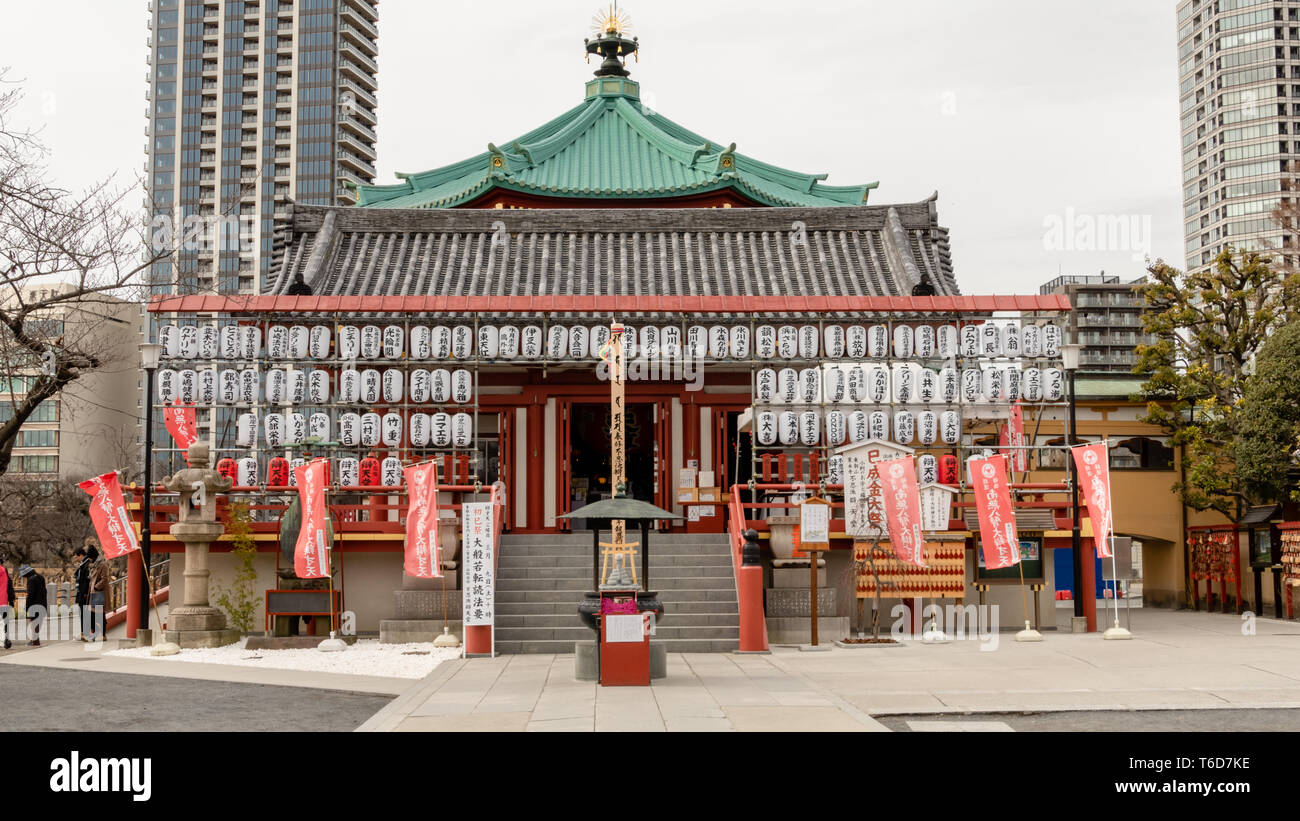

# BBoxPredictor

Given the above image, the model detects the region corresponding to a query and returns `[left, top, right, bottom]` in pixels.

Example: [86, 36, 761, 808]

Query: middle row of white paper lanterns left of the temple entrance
[157, 368, 475, 405]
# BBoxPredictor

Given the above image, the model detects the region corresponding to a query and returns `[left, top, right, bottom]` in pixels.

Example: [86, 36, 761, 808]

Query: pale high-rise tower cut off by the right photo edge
[1178, 0, 1300, 270]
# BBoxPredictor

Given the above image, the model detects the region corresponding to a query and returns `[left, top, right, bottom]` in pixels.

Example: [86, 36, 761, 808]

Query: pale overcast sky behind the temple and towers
[0, 0, 1183, 294]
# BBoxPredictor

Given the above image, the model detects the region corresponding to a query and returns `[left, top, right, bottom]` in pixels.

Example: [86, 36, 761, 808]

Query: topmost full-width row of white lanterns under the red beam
[157, 322, 1062, 361]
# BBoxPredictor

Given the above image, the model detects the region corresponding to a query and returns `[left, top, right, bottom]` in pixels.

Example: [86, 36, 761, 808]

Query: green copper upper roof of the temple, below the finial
[358, 78, 878, 208]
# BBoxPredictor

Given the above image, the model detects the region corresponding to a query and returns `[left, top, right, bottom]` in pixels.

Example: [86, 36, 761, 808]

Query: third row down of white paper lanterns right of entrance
[754, 411, 962, 447]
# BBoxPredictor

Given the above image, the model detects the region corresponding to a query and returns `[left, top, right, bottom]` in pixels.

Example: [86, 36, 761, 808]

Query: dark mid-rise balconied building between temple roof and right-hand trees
[1039, 273, 1156, 373]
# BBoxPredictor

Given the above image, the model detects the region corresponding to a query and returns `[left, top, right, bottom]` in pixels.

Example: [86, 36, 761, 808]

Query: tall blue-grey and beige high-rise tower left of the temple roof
[144, 0, 378, 294]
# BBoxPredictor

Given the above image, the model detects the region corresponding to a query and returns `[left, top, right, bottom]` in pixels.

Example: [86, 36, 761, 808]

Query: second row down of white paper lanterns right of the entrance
[754, 362, 1065, 405]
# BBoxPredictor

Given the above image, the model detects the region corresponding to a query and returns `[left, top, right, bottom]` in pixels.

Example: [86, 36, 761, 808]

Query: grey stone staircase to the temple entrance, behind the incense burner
[497, 530, 740, 653]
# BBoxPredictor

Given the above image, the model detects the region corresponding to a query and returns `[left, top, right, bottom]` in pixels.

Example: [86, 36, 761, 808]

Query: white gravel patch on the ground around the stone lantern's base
[105, 639, 460, 678]
